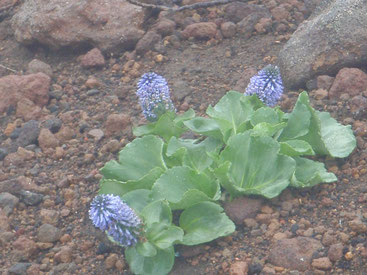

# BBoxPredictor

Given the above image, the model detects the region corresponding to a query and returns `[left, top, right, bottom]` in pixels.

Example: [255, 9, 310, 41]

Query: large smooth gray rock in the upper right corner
[278, 0, 367, 88]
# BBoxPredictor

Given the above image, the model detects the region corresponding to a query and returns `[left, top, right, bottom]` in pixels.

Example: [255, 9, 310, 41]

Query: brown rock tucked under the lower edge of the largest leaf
[224, 197, 262, 224]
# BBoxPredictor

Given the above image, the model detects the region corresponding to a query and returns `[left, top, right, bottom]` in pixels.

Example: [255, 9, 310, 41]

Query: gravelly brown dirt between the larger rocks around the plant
[0, 1, 367, 275]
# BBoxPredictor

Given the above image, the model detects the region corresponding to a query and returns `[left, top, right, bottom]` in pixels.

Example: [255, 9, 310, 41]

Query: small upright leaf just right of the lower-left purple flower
[140, 200, 172, 228]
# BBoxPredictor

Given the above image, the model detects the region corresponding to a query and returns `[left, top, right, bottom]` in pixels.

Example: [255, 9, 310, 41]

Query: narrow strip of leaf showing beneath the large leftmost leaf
[99, 167, 164, 196]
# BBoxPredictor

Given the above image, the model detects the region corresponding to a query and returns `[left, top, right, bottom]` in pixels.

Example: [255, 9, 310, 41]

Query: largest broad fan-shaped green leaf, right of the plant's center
[214, 132, 295, 198]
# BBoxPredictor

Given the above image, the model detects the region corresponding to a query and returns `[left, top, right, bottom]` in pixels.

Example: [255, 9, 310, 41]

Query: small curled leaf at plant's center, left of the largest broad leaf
[166, 137, 222, 172]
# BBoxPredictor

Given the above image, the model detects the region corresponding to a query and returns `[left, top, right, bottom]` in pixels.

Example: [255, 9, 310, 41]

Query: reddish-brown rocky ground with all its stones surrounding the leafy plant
[0, 0, 367, 275]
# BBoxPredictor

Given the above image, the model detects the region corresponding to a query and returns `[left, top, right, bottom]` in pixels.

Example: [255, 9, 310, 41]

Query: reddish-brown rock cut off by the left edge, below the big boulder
[0, 73, 51, 113]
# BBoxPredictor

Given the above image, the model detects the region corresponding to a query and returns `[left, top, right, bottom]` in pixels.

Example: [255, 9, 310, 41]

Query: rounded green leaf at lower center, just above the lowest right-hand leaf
[152, 166, 220, 209]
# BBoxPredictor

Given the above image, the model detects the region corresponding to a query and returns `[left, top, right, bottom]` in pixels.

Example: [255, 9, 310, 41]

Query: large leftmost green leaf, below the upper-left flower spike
[101, 136, 167, 182]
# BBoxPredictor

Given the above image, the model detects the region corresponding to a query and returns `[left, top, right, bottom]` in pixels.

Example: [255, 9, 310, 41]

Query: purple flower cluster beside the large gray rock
[245, 64, 284, 107]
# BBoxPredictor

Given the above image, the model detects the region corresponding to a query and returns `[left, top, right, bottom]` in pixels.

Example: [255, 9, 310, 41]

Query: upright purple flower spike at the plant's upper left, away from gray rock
[136, 73, 176, 121]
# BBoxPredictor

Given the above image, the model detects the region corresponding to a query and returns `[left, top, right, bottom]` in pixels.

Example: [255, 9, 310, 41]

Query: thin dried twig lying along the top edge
[126, 0, 249, 12]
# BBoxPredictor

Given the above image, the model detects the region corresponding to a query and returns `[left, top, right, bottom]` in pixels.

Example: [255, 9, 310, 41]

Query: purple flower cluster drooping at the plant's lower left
[89, 195, 142, 246]
